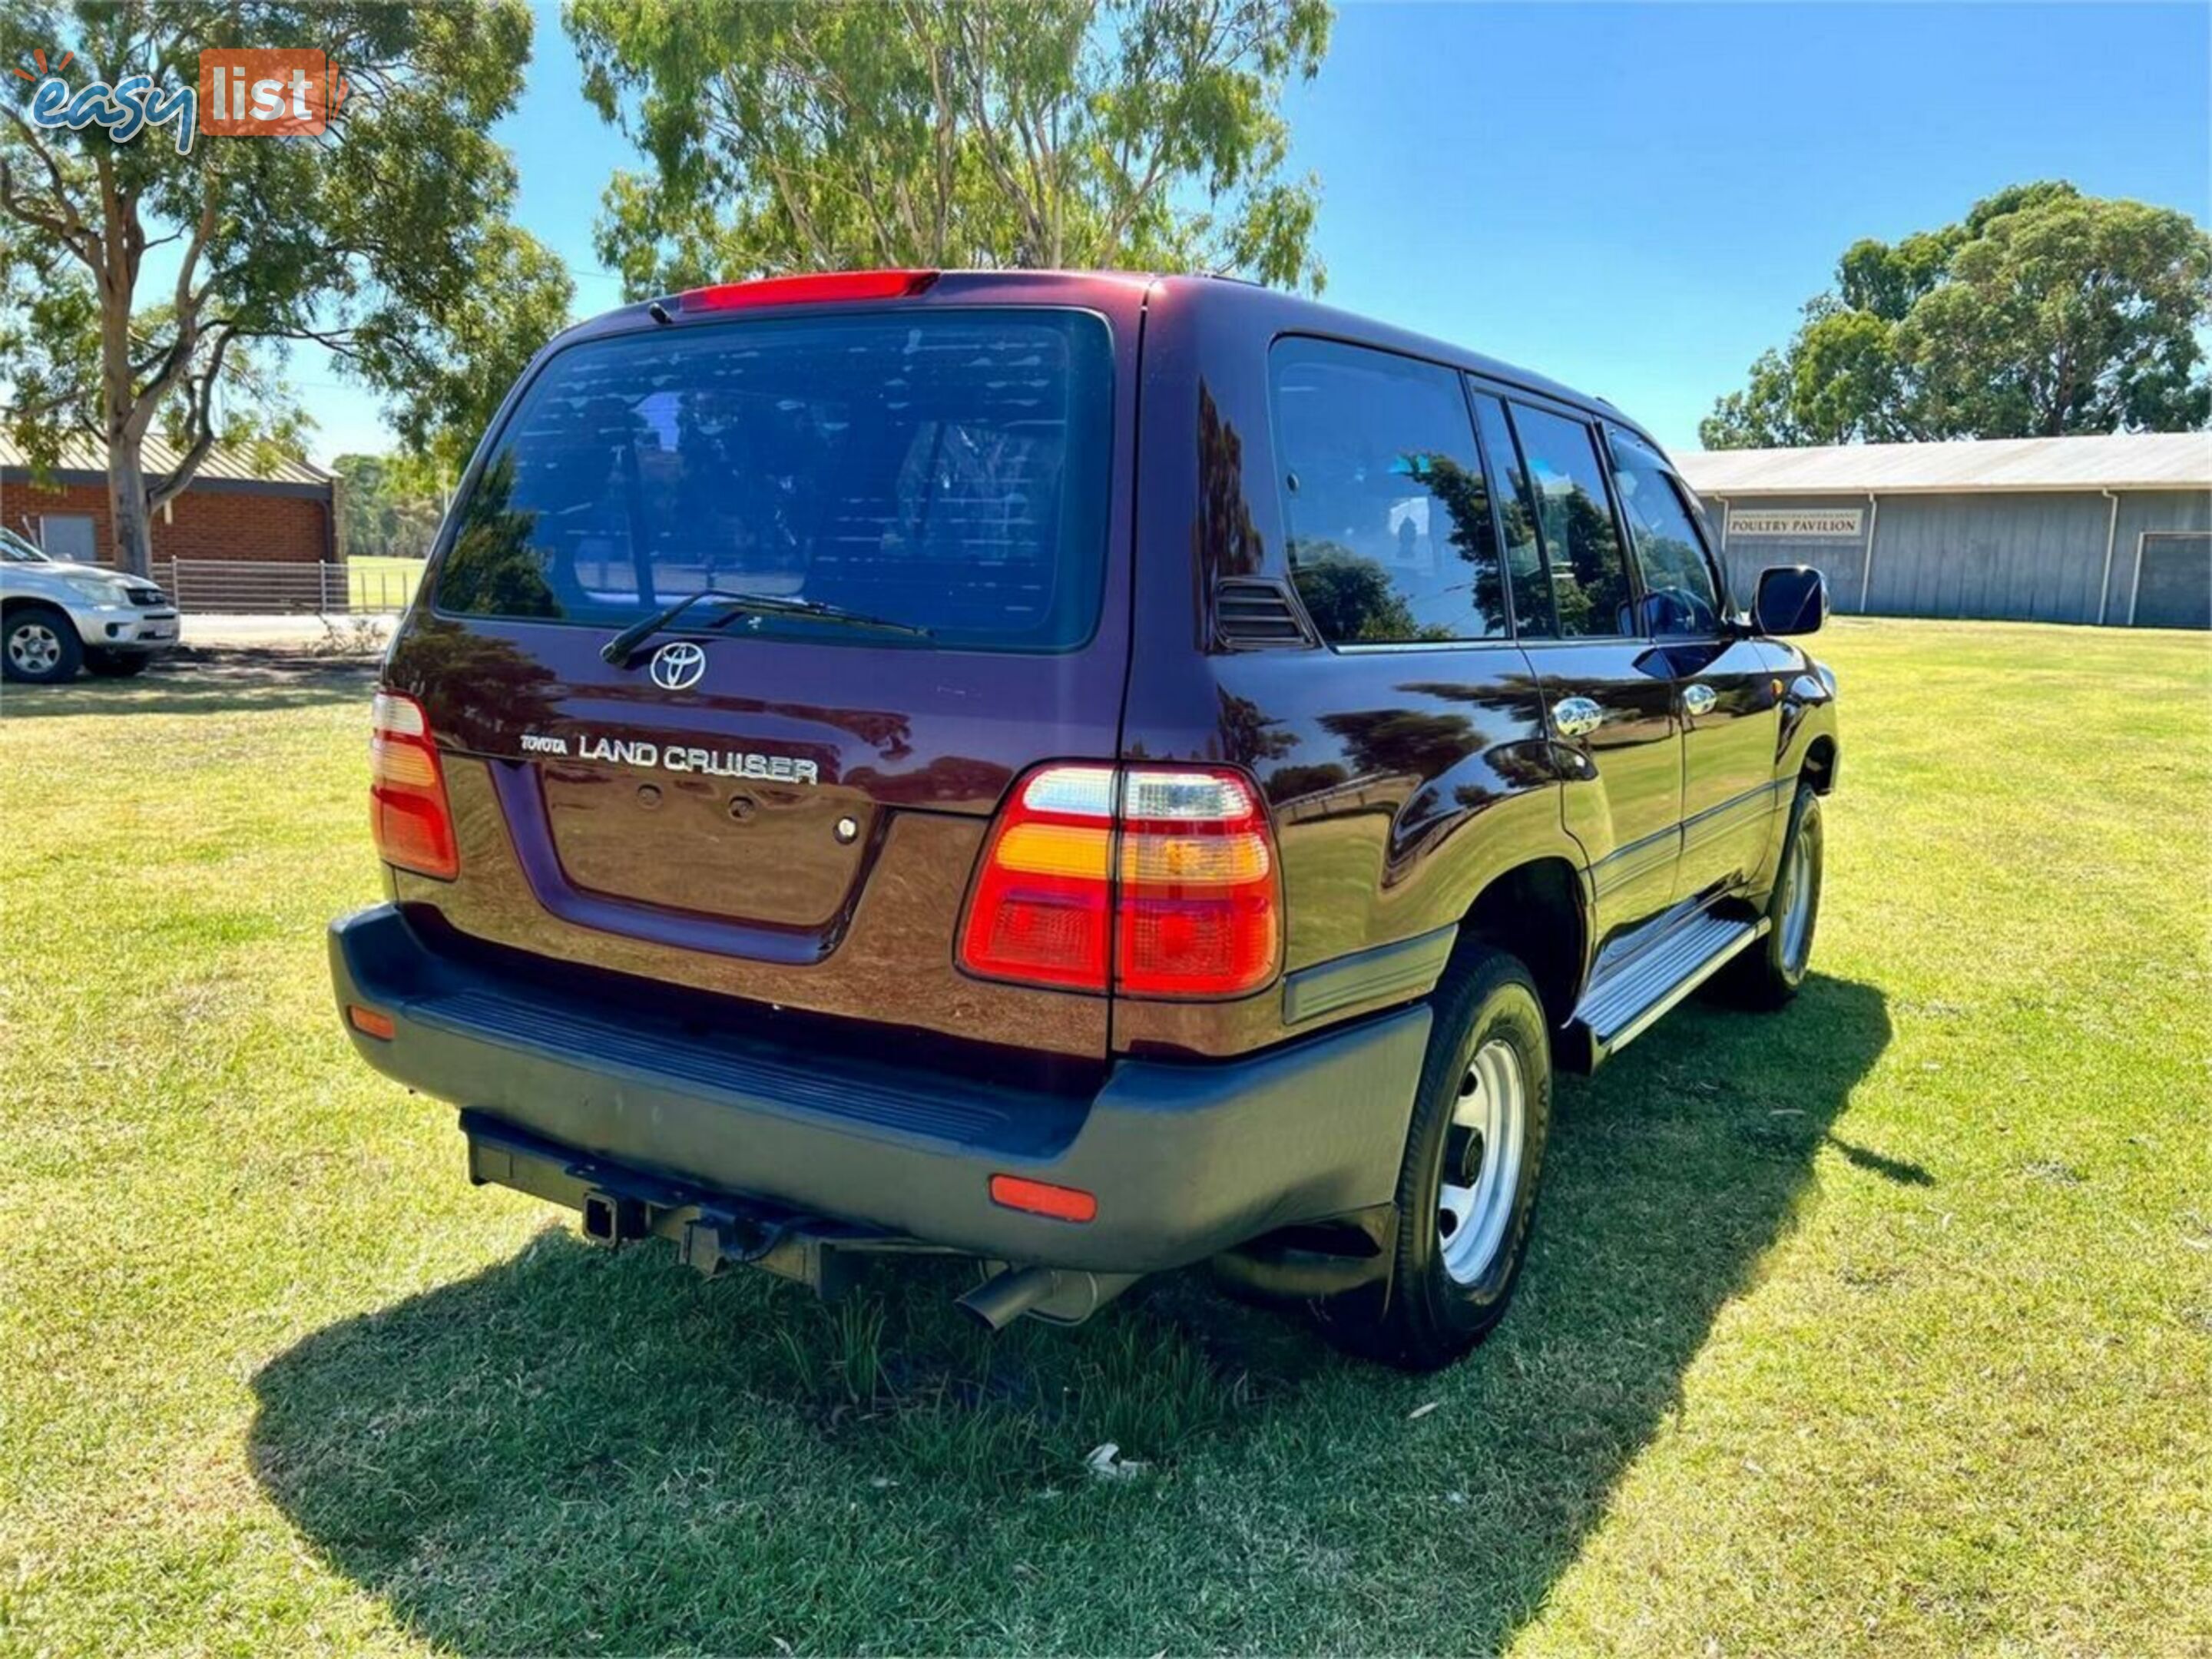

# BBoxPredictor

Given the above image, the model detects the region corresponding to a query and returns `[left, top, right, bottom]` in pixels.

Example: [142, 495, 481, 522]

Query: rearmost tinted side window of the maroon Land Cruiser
[1272, 341, 1506, 644]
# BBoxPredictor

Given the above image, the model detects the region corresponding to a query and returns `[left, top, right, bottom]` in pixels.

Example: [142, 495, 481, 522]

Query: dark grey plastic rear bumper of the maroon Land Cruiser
[329, 905, 1429, 1272]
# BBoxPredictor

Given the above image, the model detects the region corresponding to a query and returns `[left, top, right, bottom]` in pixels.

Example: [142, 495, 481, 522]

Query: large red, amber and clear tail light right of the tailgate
[960, 765, 1283, 998]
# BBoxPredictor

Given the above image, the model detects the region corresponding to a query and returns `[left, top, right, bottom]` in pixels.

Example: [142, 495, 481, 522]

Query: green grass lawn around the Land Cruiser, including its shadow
[0, 621, 2212, 1654]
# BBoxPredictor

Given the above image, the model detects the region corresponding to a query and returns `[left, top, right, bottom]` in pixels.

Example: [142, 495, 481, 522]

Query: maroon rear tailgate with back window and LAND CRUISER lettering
[389, 274, 1141, 1046]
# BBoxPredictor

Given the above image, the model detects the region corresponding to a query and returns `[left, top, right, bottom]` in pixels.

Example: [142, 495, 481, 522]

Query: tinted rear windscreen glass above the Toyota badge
[438, 310, 1113, 651]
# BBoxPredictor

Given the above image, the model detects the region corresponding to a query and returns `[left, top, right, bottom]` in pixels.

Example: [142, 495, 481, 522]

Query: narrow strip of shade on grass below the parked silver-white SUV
[0, 646, 378, 719]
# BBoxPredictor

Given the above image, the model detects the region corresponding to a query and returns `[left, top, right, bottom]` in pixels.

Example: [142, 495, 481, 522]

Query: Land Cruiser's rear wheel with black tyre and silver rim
[1320, 951, 1551, 1372]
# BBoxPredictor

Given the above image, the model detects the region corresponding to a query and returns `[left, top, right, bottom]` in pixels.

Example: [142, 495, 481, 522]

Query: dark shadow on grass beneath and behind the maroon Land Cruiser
[250, 978, 1893, 1652]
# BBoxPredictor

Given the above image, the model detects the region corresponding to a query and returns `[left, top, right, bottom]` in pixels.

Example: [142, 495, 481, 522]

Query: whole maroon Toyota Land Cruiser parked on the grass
[329, 272, 1836, 1365]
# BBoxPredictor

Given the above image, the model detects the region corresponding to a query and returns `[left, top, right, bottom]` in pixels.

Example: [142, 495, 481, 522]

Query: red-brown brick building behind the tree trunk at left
[0, 435, 341, 566]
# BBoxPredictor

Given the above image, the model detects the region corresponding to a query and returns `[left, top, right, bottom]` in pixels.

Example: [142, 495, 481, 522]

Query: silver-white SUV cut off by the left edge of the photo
[0, 526, 177, 686]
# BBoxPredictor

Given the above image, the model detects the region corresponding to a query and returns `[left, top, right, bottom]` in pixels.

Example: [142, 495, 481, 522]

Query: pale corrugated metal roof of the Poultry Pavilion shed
[1674, 432, 2212, 498]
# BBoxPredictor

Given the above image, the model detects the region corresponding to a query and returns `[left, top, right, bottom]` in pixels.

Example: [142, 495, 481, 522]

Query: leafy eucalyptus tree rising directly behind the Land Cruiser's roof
[564, 0, 1332, 296]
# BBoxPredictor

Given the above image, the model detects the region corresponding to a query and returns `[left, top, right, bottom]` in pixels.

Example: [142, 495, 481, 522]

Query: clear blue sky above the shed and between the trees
[294, 5, 2212, 460]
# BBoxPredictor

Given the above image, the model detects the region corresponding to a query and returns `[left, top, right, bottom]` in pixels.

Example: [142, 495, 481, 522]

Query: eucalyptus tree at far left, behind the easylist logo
[0, 0, 571, 573]
